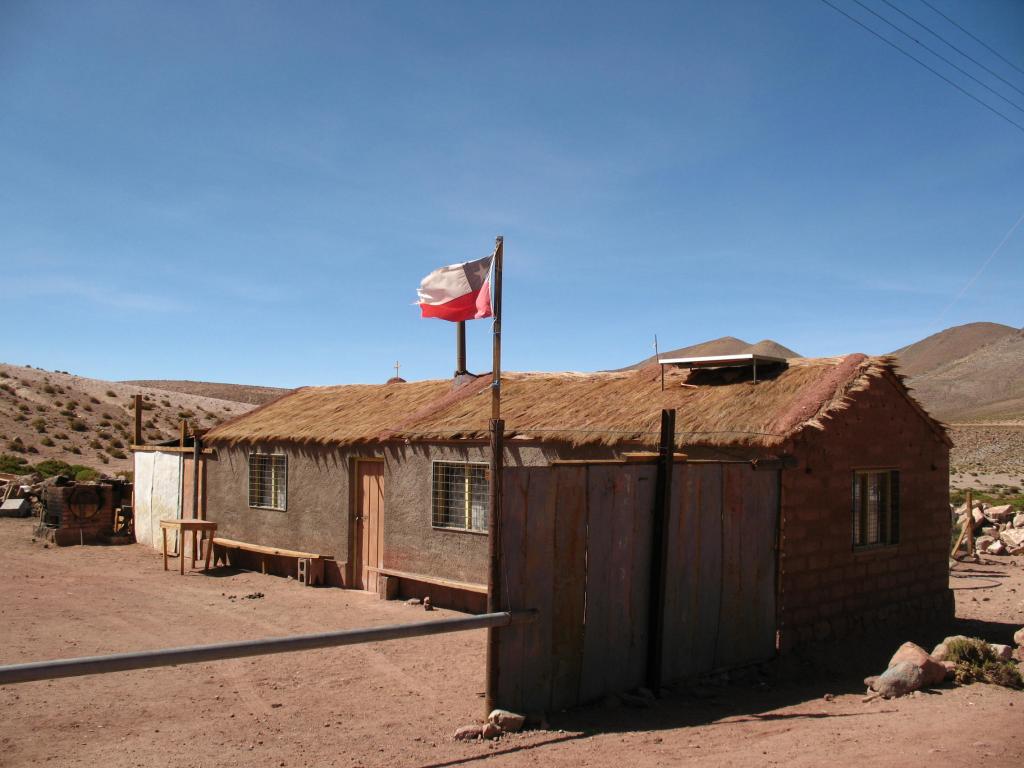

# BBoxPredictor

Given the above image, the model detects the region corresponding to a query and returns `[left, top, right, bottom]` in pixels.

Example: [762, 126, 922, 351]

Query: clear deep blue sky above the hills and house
[0, 0, 1024, 386]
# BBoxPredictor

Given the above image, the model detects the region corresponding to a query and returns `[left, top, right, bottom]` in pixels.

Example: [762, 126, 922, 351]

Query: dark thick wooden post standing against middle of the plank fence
[647, 409, 676, 695]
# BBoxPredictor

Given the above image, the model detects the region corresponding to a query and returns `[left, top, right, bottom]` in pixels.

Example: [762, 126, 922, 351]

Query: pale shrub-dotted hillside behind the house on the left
[0, 364, 254, 474]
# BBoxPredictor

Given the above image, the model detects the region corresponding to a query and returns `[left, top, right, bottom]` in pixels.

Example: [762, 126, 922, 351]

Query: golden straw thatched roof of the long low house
[206, 354, 948, 447]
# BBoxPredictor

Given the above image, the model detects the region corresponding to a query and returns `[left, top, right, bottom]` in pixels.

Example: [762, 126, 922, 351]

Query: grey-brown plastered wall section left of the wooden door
[205, 445, 380, 584]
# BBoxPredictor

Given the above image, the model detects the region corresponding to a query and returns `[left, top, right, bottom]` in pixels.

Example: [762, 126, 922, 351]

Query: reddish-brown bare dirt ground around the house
[0, 519, 1024, 768]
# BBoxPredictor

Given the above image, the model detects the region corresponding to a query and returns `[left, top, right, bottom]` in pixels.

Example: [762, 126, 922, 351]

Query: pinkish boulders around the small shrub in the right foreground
[864, 628, 1024, 701]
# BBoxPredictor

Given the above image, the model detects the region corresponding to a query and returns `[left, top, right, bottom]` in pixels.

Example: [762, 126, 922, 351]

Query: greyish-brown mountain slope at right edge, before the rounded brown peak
[908, 324, 1024, 421]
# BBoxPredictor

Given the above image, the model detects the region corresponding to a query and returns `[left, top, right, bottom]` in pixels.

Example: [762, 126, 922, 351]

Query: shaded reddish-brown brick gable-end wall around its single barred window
[779, 379, 952, 650]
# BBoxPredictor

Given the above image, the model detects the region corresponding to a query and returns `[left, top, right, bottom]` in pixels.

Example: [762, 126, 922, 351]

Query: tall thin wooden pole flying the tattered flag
[484, 234, 505, 714]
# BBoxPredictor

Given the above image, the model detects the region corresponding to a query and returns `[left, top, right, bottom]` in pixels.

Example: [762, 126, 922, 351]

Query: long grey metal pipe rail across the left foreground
[0, 610, 537, 685]
